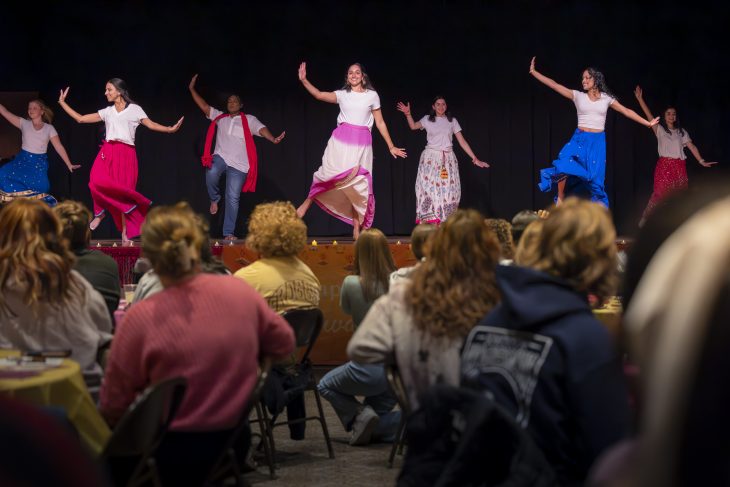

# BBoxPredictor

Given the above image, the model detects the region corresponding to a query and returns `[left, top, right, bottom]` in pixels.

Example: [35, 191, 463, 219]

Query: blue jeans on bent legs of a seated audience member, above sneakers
[317, 362, 400, 441]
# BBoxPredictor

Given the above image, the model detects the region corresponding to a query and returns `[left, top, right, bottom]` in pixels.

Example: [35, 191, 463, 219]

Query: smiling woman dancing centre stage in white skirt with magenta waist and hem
[297, 63, 406, 239]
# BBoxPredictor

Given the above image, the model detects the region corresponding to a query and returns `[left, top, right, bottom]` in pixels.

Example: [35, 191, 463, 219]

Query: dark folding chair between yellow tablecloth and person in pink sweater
[100, 377, 187, 487]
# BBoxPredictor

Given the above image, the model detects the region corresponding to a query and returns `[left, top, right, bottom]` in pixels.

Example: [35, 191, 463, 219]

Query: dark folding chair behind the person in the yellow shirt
[256, 308, 335, 475]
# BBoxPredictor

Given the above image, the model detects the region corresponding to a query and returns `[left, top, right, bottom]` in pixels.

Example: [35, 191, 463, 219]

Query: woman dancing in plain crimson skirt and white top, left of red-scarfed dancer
[58, 78, 183, 245]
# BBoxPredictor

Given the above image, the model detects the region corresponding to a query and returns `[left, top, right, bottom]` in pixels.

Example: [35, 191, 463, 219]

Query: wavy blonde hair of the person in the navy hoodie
[518, 197, 618, 303]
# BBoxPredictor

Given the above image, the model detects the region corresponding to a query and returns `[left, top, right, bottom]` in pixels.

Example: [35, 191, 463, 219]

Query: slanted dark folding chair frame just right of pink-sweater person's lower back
[207, 357, 274, 487]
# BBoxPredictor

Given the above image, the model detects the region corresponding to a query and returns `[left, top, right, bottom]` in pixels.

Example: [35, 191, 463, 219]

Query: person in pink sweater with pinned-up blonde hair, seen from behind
[100, 203, 295, 485]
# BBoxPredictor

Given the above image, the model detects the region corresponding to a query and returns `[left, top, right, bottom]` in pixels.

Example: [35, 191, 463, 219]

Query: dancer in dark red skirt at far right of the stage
[634, 86, 717, 226]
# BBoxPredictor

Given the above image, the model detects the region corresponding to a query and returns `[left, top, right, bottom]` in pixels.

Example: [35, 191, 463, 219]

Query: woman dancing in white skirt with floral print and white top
[397, 96, 489, 225]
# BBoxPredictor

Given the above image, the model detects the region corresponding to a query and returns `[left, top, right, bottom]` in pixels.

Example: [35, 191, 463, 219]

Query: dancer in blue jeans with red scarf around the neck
[189, 74, 286, 240]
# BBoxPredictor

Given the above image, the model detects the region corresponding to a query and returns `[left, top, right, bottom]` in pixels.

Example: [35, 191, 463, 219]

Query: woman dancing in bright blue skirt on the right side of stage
[530, 57, 659, 207]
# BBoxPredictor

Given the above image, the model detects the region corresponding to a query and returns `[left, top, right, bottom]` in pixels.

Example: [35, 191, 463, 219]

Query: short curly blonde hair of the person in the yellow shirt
[246, 201, 307, 257]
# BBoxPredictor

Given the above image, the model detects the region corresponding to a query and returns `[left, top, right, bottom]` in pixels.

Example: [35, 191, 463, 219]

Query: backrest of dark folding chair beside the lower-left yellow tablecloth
[101, 377, 187, 458]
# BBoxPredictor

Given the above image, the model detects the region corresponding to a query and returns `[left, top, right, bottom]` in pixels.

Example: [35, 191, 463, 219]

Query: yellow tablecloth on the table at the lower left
[0, 350, 111, 454]
